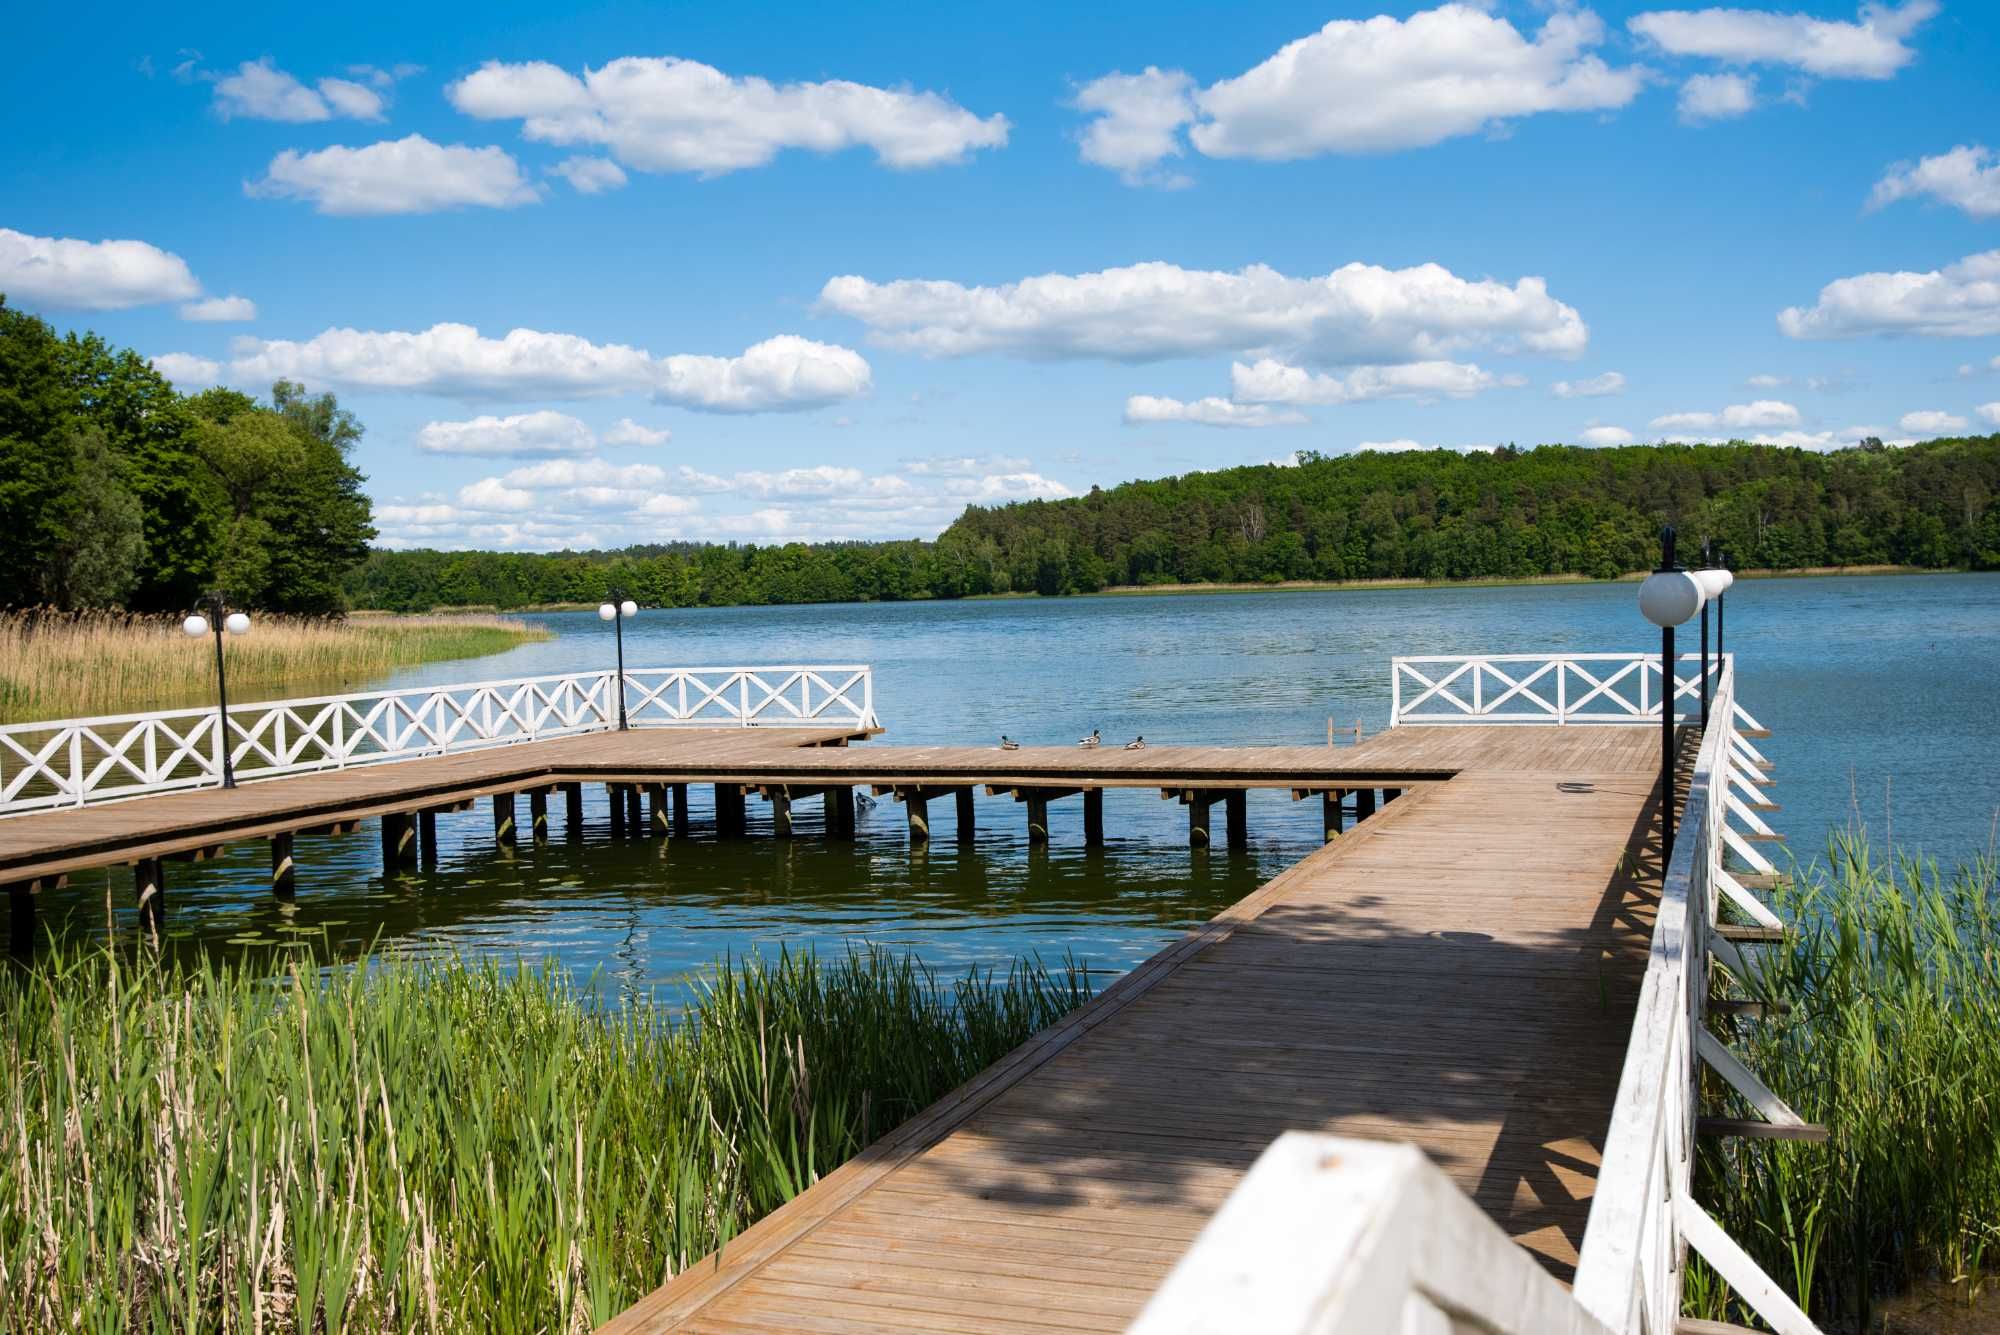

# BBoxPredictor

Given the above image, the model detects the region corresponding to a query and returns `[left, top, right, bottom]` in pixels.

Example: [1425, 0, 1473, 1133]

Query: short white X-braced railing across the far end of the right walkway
[1390, 654, 1734, 725]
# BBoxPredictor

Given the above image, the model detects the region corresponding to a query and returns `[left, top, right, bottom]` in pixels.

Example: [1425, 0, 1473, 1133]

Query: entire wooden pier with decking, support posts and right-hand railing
[0, 656, 1810, 1335]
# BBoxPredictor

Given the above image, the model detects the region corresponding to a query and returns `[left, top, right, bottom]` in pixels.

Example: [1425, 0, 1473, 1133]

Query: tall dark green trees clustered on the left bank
[0, 298, 374, 614]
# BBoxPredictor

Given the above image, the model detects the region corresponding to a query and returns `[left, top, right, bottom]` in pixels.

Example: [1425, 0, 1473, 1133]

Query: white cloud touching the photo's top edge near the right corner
[1628, 0, 1938, 78]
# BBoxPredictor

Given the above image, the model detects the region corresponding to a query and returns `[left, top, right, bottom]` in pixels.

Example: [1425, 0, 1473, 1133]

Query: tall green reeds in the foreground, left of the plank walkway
[0, 947, 1086, 1333]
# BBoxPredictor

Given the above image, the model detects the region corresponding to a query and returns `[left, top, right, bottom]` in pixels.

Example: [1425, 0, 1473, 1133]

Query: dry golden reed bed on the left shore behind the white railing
[0, 612, 550, 723]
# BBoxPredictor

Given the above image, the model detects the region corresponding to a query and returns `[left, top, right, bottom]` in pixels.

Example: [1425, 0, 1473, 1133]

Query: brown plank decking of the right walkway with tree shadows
[606, 727, 1658, 1335]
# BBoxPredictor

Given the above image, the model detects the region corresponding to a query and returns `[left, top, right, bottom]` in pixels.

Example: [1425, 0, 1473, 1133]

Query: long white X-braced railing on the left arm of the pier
[0, 666, 876, 817]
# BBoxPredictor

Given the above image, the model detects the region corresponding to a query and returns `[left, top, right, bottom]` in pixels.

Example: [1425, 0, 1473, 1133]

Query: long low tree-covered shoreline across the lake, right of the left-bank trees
[346, 436, 2000, 610]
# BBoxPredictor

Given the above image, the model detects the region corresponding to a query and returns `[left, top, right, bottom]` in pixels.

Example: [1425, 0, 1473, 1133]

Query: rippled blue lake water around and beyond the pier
[19, 576, 2000, 989]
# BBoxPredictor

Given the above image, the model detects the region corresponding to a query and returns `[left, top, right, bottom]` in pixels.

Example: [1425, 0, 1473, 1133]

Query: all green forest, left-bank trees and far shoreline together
[0, 298, 2000, 616]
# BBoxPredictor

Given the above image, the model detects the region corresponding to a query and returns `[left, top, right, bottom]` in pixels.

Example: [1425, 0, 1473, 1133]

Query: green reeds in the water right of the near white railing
[1688, 835, 2000, 1331]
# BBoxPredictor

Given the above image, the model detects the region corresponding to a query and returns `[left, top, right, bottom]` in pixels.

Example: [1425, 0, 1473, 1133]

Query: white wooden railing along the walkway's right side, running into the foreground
[1132, 654, 1818, 1335]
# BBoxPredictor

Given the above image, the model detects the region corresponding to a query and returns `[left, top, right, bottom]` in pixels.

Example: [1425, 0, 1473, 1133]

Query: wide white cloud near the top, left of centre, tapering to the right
[456, 56, 1008, 174]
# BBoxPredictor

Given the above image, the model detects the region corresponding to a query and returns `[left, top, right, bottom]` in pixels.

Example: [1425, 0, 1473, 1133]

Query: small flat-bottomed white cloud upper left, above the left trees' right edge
[244, 134, 542, 216]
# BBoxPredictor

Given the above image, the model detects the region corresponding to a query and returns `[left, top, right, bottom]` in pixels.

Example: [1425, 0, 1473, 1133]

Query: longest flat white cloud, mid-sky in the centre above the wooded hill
[820, 262, 1590, 366]
